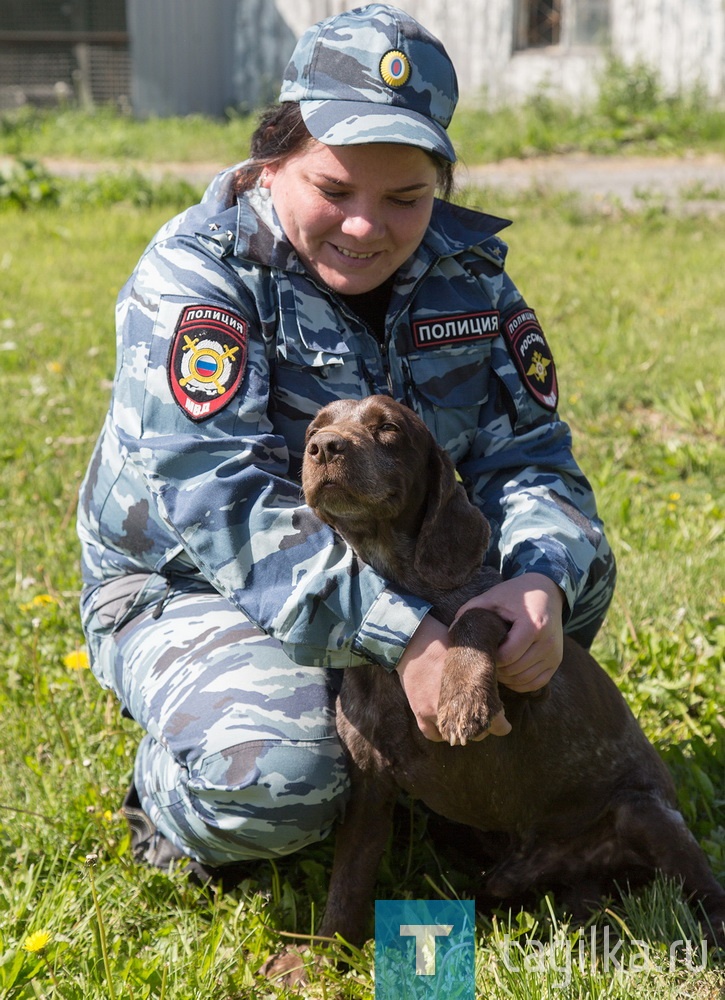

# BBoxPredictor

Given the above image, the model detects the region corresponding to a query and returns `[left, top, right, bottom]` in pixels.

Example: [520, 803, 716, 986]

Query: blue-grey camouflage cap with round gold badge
[279, 3, 458, 163]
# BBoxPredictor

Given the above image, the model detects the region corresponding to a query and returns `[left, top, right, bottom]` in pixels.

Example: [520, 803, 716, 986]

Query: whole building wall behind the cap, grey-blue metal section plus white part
[127, 0, 725, 115]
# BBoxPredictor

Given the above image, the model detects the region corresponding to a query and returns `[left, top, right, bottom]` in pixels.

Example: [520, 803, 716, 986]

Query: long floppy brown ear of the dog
[413, 441, 491, 590]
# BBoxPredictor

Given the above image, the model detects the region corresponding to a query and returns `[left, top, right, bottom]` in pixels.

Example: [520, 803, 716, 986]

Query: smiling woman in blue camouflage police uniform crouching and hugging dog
[79, 4, 614, 873]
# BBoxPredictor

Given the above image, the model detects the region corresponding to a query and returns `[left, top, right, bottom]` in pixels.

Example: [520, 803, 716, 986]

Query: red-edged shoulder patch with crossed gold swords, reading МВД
[168, 305, 247, 421]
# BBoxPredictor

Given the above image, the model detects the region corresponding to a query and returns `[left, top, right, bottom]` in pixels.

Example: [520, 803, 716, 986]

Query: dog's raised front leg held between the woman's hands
[438, 608, 506, 746]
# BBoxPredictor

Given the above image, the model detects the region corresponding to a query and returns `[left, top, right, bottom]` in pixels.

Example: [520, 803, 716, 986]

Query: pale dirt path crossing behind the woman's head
[0, 153, 725, 214]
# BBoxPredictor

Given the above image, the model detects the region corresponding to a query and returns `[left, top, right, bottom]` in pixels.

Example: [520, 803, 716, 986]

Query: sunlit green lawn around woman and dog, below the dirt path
[0, 158, 725, 1000]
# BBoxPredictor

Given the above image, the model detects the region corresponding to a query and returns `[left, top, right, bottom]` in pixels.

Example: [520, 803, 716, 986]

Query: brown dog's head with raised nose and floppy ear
[302, 396, 489, 589]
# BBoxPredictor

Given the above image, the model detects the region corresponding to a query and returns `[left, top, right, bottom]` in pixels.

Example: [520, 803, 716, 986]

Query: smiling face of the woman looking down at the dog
[261, 142, 437, 295]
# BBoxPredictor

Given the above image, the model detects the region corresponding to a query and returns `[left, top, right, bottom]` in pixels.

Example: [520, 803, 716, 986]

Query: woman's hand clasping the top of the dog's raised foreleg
[456, 573, 564, 691]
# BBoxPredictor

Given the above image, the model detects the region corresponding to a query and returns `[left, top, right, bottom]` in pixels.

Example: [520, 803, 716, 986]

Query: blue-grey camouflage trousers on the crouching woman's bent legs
[84, 543, 615, 866]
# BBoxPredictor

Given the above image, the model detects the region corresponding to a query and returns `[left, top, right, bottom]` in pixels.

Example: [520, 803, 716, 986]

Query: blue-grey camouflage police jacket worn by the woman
[78, 168, 601, 669]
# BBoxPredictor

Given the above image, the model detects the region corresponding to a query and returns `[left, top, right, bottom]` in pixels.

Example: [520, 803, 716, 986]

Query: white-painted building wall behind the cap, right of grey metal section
[232, 0, 725, 114]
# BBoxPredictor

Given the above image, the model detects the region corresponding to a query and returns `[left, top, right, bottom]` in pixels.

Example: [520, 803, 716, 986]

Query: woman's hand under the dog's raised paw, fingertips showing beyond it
[395, 615, 511, 743]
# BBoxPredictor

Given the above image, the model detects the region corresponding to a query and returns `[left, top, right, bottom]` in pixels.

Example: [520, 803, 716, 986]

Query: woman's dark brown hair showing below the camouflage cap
[234, 101, 453, 201]
